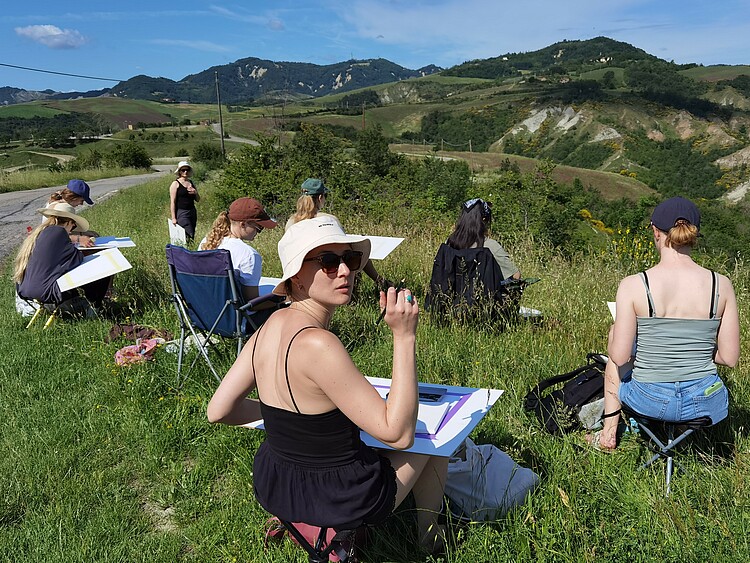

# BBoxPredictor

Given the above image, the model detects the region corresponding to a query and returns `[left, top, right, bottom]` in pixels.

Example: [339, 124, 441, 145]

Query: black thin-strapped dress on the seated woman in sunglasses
[253, 327, 396, 529]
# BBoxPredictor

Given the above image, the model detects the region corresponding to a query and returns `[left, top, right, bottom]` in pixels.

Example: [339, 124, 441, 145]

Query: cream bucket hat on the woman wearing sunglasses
[273, 215, 372, 295]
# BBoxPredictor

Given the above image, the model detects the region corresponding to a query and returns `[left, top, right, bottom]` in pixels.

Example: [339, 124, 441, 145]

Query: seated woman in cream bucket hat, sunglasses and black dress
[208, 217, 448, 551]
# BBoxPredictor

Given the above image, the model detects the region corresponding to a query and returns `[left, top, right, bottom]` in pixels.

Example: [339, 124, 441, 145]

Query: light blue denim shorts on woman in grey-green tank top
[620, 374, 729, 424]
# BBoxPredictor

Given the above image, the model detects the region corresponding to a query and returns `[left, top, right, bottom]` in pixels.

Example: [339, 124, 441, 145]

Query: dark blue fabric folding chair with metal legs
[166, 244, 279, 387]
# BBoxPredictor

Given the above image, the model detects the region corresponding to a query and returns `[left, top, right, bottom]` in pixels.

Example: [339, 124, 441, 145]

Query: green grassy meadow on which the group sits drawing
[0, 174, 750, 562]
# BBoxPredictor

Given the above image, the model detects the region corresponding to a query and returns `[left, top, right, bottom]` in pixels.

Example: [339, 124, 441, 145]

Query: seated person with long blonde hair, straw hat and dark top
[13, 203, 111, 306]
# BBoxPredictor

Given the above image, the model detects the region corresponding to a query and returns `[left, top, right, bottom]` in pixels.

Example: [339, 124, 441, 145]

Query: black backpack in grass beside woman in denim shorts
[523, 352, 607, 434]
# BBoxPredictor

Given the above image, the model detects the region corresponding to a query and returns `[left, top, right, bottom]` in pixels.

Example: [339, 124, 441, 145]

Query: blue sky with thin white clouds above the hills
[0, 0, 750, 91]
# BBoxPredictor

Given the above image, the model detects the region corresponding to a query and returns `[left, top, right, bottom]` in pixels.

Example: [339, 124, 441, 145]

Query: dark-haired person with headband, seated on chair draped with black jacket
[446, 198, 521, 280]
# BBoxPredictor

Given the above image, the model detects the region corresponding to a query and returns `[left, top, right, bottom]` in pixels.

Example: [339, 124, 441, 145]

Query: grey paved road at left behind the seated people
[0, 164, 174, 260]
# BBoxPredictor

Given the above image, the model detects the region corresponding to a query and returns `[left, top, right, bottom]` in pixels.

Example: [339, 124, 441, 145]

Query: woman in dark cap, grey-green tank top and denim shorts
[594, 197, 740, 449]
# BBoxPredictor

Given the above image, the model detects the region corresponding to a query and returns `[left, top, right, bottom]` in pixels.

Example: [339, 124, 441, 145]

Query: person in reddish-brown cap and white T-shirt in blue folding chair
[198, 197, 276, 307]
